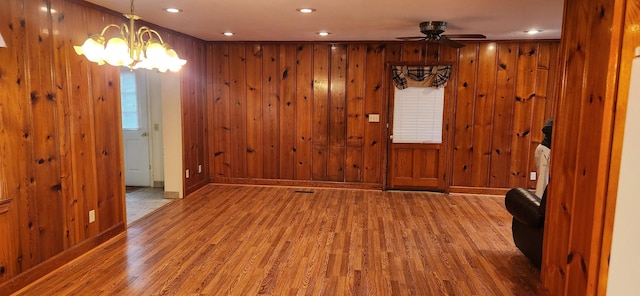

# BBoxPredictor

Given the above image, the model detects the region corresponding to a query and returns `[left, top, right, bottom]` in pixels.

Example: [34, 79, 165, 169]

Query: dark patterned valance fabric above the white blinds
[392, 66, 451, 89]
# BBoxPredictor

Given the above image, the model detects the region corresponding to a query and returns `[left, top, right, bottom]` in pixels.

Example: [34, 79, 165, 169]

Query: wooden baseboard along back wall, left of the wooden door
[211, 178, 382, 190]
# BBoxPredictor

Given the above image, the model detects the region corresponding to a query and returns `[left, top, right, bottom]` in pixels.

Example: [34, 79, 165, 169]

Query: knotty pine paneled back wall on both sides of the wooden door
[207, 41, 558, 189]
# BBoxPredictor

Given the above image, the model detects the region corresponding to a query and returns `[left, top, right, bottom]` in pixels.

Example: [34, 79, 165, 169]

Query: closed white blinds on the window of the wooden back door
[393, 87, 444, 143]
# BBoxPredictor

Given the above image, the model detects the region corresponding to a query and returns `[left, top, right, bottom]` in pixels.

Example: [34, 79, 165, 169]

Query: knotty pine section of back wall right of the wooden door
[451, 42, 558, 188]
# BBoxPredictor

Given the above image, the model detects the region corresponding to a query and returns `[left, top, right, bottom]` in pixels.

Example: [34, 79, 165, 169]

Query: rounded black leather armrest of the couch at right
[504, 187, 544, 227]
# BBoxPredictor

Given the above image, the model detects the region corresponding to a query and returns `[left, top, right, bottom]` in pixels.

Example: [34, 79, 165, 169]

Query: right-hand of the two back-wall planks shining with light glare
[327, 44, 347, 182]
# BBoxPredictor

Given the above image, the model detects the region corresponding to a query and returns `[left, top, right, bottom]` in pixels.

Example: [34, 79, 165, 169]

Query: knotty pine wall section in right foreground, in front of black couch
[539, 0, 640, 295]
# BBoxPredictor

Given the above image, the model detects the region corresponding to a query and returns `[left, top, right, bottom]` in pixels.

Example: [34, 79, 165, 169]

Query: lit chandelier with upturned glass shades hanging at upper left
[73, 0, 187, 72]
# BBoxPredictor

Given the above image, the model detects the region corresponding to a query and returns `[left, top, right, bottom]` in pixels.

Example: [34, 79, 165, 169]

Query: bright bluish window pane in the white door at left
[120, 67, 140, 130]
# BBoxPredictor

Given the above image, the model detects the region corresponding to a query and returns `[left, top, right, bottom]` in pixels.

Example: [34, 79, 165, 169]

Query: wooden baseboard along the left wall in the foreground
[0, 222, 126, 295]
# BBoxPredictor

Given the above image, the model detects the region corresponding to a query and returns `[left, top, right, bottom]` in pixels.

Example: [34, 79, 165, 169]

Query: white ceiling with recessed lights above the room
[87, 0, 564, 41]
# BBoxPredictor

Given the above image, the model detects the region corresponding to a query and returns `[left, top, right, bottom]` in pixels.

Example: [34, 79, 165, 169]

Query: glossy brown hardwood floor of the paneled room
[12, 184, 539, 295]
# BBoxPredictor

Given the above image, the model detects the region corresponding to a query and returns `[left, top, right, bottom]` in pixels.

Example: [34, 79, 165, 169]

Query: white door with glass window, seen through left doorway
[120, 68, 151, 187]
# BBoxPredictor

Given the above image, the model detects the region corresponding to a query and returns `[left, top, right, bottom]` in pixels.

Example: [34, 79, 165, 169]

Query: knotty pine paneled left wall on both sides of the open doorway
[0, 0, 209, 294]
